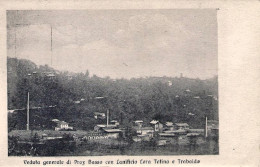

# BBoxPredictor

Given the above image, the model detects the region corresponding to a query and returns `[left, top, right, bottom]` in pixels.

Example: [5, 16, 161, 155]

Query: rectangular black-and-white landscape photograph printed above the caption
[6, 8, 219, 157]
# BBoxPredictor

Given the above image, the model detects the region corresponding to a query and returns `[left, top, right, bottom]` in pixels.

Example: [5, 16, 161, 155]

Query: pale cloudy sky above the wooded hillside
[7, 9, 217, 79]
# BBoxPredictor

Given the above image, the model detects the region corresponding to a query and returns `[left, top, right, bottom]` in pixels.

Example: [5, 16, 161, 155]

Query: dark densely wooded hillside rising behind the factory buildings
[7, 58, 218, 131]
